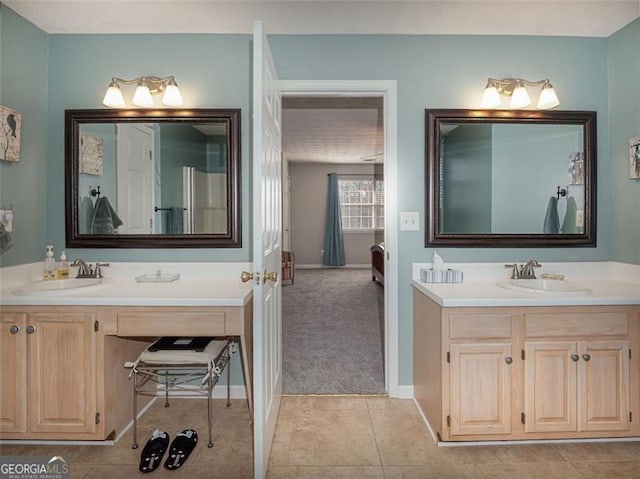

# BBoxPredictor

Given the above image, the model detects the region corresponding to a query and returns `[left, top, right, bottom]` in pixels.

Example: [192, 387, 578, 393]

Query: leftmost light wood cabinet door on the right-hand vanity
[450, 342, 513, 436]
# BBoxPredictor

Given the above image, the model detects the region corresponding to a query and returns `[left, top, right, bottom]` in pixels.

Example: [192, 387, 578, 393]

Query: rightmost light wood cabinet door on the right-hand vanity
[578, 341, 630, 431]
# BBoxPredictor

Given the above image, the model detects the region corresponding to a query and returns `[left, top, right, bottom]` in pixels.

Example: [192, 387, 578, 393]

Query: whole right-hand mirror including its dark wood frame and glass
[425, 109, 597, 247]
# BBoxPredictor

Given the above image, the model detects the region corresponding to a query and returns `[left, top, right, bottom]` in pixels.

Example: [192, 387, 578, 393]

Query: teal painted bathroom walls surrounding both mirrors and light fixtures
[1, 7, 640, 384]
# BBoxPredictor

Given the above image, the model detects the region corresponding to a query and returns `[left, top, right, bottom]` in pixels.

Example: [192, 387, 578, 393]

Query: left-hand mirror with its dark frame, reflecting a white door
[65, 109, 242, 248]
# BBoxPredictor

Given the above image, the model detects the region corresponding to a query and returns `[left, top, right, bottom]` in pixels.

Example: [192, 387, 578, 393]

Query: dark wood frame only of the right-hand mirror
[425, 109, 597, 248]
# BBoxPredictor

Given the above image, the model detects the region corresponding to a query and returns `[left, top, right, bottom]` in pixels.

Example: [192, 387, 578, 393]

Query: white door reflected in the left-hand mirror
[116, 124, 155, 234]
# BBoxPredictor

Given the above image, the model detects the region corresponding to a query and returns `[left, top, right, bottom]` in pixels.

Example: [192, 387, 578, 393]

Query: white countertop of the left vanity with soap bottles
[0, 263, 253, 306]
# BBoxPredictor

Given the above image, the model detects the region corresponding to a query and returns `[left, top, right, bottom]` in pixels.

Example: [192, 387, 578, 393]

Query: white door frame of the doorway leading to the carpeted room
[280, 80, 400, 398]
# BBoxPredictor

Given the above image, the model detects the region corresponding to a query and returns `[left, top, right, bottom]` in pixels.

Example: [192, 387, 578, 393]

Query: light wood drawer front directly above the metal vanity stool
[118, 311, 227, 336]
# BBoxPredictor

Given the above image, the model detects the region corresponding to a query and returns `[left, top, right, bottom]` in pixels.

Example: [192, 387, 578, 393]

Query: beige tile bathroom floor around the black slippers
[0, 396, 640, 479]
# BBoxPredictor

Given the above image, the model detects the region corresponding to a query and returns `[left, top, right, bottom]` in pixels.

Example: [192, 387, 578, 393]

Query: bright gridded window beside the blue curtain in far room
[338, 175, 384, 231]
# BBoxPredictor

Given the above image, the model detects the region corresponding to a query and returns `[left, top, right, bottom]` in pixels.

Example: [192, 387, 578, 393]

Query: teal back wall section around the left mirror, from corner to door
[46, 35, 251, 261]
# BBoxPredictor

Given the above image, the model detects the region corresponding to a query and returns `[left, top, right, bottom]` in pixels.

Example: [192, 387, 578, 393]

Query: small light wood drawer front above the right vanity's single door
[449, 313, 511, 339]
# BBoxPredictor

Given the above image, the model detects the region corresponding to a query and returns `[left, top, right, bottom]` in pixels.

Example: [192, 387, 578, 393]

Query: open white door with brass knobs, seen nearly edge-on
[253, 22, 282, 479]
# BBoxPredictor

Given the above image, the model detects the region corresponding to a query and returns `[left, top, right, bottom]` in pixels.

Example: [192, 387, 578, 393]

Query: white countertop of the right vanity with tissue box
[411, 262, 640, 307]
